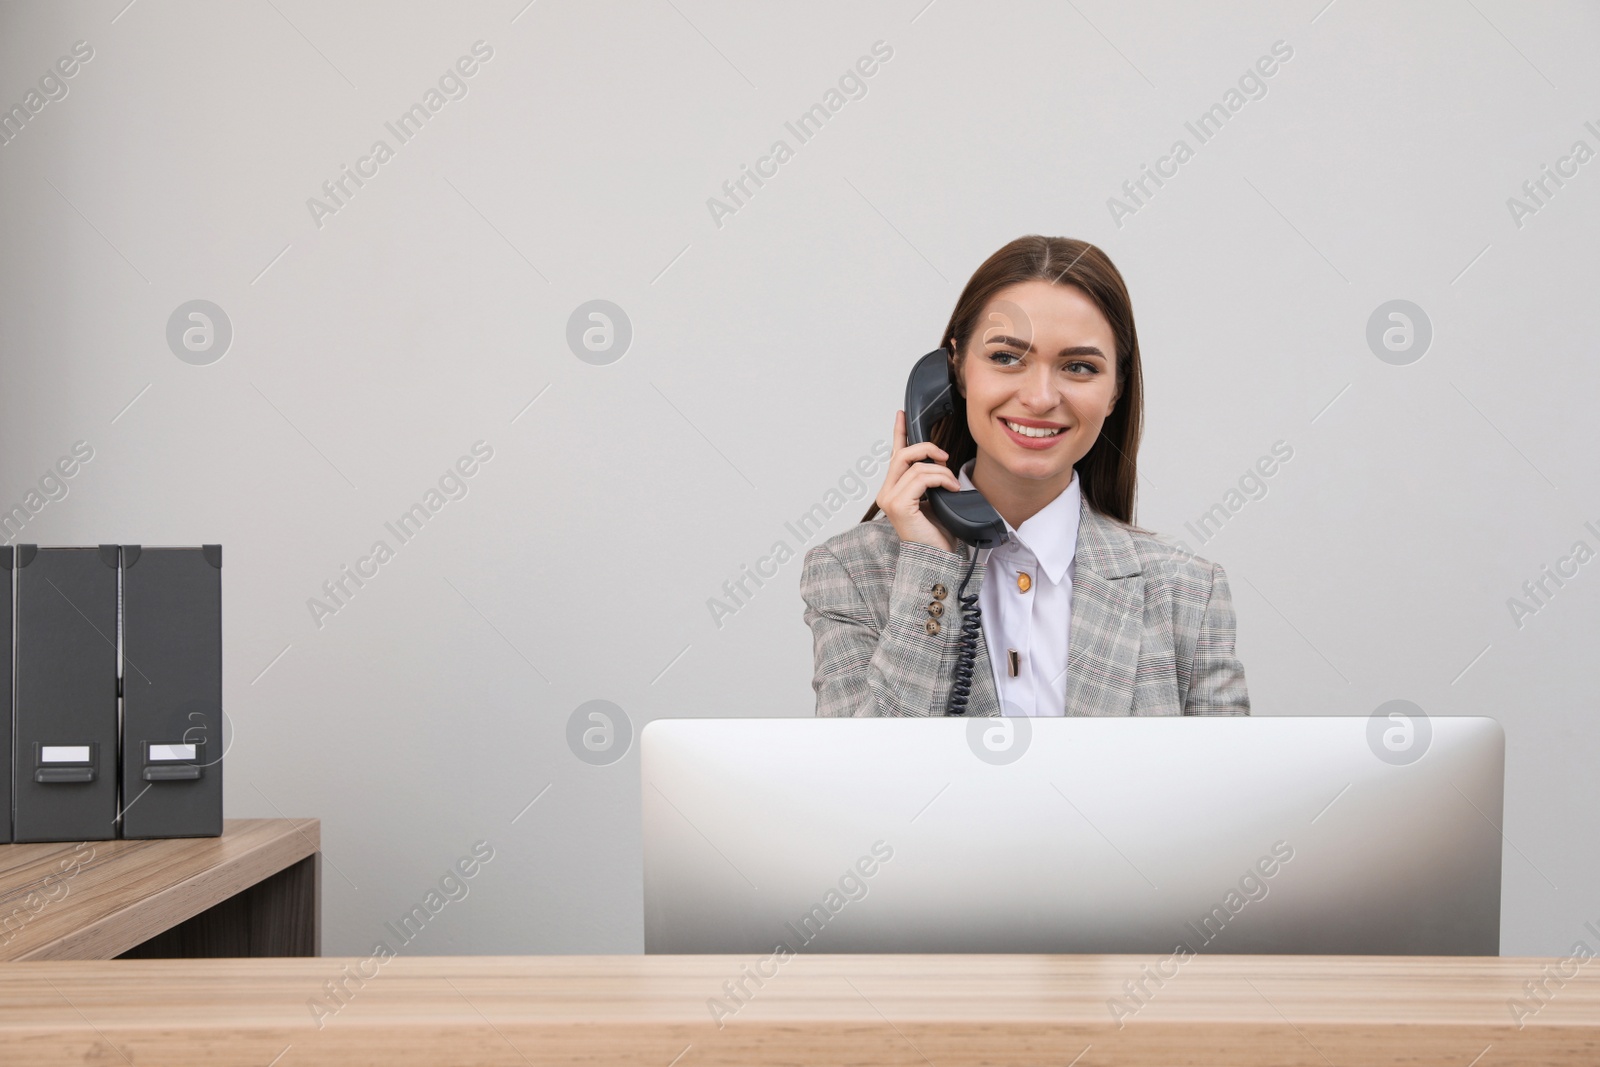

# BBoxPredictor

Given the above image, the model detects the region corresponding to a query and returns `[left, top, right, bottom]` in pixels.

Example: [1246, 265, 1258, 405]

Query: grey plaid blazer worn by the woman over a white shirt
[800, 499, 1250, 717]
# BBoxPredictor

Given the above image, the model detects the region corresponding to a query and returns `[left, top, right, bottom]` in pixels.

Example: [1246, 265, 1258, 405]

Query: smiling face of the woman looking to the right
[958, 282, 1122, 493]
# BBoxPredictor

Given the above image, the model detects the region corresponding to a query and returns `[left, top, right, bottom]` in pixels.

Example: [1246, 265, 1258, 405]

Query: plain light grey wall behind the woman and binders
[0, 0, 1600, 955]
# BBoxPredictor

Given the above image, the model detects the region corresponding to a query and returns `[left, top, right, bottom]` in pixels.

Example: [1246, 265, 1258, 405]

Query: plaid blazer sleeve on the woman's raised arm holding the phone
[800, 541, 966, 717]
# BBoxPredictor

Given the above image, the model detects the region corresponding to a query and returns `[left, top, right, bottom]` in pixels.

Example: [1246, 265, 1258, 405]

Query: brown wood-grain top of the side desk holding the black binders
[0, 819, 322, 960]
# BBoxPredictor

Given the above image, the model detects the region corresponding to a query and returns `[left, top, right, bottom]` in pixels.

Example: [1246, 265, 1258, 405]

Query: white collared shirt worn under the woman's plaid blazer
[958, 459, 1082, 715]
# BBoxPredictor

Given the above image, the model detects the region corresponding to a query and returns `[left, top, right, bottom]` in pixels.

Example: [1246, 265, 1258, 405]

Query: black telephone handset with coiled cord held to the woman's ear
[906, 349, 1011, 715]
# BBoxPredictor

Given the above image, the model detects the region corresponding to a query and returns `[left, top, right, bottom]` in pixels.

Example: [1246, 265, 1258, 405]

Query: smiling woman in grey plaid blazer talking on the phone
[800, 235, 1250, 715]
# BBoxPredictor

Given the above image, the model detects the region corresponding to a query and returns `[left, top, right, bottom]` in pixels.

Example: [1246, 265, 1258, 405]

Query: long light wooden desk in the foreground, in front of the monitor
[0, 955, 1600, 1067]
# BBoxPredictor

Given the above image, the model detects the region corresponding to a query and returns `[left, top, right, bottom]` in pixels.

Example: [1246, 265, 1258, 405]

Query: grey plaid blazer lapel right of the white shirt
[1066, 498, 1144, 715]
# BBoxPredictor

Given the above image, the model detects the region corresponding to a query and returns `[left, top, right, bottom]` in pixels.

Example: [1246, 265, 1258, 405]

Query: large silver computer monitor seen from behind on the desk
[640, 709, 1506, 958]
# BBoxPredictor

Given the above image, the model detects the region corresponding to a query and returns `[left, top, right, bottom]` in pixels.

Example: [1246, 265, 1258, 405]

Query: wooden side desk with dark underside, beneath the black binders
[0, 819, 322, 960]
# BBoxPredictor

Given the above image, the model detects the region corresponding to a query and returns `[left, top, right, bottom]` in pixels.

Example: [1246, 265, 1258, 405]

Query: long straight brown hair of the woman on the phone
[861, 234, 1144, 526]
